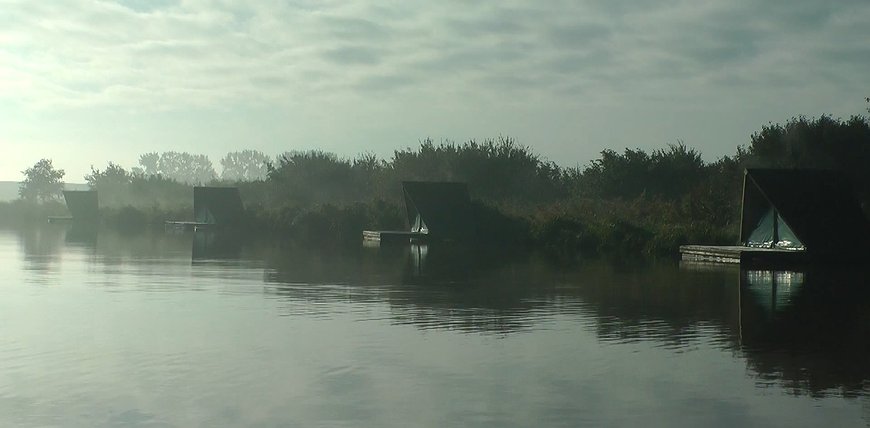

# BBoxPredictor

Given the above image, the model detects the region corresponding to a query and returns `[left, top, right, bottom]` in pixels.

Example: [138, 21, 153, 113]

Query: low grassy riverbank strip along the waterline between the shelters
[0, 196, 736, 257]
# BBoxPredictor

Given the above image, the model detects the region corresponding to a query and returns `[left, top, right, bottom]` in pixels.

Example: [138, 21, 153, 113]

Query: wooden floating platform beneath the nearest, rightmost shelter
[680, 245, 809, 265]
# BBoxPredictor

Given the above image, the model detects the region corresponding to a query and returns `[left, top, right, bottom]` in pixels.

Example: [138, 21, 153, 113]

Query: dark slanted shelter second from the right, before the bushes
[402, 181, 474, 240]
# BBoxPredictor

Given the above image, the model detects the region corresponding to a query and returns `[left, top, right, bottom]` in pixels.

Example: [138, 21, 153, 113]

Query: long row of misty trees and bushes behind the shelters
[0, 112, 870, 256]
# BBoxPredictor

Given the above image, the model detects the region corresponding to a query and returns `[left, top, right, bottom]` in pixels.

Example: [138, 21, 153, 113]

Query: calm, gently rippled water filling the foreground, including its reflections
[0, 227, 870, 427]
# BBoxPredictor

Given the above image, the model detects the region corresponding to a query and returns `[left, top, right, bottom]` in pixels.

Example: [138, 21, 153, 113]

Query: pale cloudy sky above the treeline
[0, 0, 870, 182]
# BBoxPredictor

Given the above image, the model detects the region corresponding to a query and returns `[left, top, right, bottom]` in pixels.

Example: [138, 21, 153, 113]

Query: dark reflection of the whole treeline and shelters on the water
[11, 227, 870, 397]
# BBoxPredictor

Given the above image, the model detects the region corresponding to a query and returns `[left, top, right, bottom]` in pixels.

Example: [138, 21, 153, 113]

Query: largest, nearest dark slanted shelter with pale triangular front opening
[740, 169, 870, 255]
